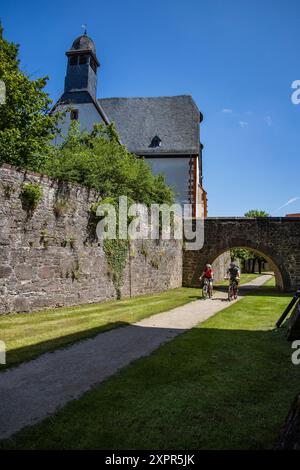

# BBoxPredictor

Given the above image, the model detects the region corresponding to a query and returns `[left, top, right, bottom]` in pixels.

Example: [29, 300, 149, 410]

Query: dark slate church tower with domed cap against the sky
[64, 32, 100, 100]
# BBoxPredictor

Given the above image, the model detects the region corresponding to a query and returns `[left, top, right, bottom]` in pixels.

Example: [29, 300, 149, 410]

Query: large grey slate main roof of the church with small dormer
[98, 95, 202, 155]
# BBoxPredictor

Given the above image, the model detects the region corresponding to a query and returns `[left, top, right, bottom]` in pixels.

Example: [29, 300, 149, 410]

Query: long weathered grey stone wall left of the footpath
[0, 165, 182, 313]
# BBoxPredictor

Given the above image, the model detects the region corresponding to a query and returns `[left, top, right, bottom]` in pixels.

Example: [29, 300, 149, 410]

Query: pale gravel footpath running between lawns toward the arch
[0, 275, 270, 439]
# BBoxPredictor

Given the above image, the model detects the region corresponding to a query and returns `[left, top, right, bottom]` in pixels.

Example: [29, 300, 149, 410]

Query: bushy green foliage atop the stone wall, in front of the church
[44, 121, 174, 205]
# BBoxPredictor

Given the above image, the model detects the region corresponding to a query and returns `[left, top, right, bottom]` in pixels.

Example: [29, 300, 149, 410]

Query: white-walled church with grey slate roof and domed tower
[53, 34, 207, 217]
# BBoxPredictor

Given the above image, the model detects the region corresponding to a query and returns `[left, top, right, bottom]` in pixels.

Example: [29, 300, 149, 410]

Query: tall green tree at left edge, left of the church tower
[0, 24, 59, 170]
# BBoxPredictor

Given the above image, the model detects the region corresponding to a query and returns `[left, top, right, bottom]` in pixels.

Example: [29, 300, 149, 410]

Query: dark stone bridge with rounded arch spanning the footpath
[183, 217, 300, 291]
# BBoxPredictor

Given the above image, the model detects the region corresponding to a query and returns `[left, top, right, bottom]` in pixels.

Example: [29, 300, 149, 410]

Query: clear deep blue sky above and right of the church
[0, 0, 300, 216]
